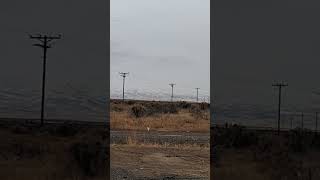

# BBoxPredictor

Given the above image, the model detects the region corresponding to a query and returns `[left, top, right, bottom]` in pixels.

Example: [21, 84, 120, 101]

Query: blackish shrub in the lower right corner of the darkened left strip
[71, 142, 107, 176]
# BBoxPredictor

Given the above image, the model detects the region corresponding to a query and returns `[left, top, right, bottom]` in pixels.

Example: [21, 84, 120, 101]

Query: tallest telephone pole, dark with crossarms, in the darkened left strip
[29, 34, 61, 126]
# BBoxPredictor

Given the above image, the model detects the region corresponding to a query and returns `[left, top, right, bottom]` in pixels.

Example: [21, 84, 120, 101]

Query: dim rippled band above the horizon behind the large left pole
[0, 88, 107, 121]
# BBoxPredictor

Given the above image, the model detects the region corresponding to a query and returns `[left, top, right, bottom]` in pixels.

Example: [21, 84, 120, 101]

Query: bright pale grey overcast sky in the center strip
[110, 0, 210, 98]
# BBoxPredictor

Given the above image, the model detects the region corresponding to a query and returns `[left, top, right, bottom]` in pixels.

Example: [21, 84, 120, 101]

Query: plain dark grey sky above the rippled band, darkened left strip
[0, 0, 108, 92]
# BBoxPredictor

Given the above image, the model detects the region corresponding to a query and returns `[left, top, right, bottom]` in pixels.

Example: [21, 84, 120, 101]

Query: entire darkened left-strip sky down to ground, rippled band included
[0, 0, 109, 120]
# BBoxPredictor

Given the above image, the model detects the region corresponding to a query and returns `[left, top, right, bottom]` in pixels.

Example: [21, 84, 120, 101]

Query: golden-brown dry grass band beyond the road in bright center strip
[110, 102, 210, 132]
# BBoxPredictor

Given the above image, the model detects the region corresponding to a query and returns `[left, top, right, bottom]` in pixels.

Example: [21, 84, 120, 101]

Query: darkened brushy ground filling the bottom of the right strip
[211, 125, 320, 180]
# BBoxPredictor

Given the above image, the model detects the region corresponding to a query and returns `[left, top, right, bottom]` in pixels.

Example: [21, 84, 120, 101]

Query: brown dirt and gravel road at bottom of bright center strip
[110, 131, 210, 180]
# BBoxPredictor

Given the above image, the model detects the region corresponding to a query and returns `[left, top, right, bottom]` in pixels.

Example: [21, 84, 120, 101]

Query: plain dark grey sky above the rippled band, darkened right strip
[211, 0, 320, 111]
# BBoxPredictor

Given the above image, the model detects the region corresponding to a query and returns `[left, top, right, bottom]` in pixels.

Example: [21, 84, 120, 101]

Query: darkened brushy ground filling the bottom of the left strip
[0, 124, 108, 180]
